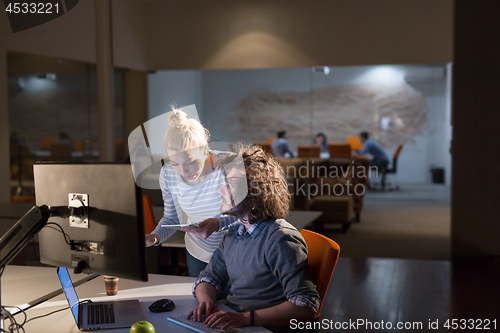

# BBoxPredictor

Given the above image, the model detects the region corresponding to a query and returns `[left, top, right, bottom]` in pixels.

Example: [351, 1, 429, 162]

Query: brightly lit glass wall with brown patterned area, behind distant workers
[148, 64, 451, 184]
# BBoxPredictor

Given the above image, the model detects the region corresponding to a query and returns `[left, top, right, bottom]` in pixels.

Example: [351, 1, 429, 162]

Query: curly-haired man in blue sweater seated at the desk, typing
[188, 147, 320, 329]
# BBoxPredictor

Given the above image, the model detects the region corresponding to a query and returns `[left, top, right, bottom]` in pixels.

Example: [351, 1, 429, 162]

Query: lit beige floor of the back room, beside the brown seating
[322, 184, 451, 260]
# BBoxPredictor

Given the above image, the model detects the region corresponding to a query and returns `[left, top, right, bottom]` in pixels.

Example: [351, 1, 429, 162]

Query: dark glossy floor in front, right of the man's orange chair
[320, 257, 500, 332]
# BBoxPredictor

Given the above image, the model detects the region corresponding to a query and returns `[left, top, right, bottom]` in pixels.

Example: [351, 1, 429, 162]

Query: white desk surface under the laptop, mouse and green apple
[1, 266, 269, 333]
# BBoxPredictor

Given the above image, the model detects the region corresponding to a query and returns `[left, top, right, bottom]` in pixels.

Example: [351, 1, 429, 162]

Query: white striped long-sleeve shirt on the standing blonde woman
[153, 152, 237, 262]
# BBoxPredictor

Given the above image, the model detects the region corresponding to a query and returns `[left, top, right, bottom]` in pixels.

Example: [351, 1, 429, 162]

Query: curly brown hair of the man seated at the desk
[225, 144, 290, 224]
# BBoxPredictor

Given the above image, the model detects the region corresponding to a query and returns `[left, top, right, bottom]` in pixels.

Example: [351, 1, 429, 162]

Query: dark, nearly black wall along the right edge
[451, 0, 500, 259]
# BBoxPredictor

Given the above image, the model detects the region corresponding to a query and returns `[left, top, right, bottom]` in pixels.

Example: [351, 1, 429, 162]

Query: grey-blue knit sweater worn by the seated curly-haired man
[193, 220, 320, 313]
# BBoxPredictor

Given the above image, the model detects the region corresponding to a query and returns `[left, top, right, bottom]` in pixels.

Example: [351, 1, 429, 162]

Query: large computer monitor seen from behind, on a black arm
[34, 162, 148, 281]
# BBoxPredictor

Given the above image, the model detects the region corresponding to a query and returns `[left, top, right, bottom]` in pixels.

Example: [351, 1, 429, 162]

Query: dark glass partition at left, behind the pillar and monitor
[7, 53, 126, 201]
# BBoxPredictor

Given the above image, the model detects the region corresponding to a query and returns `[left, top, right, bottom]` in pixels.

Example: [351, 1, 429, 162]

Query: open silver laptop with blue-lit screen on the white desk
[57, 267, 144, 331]
